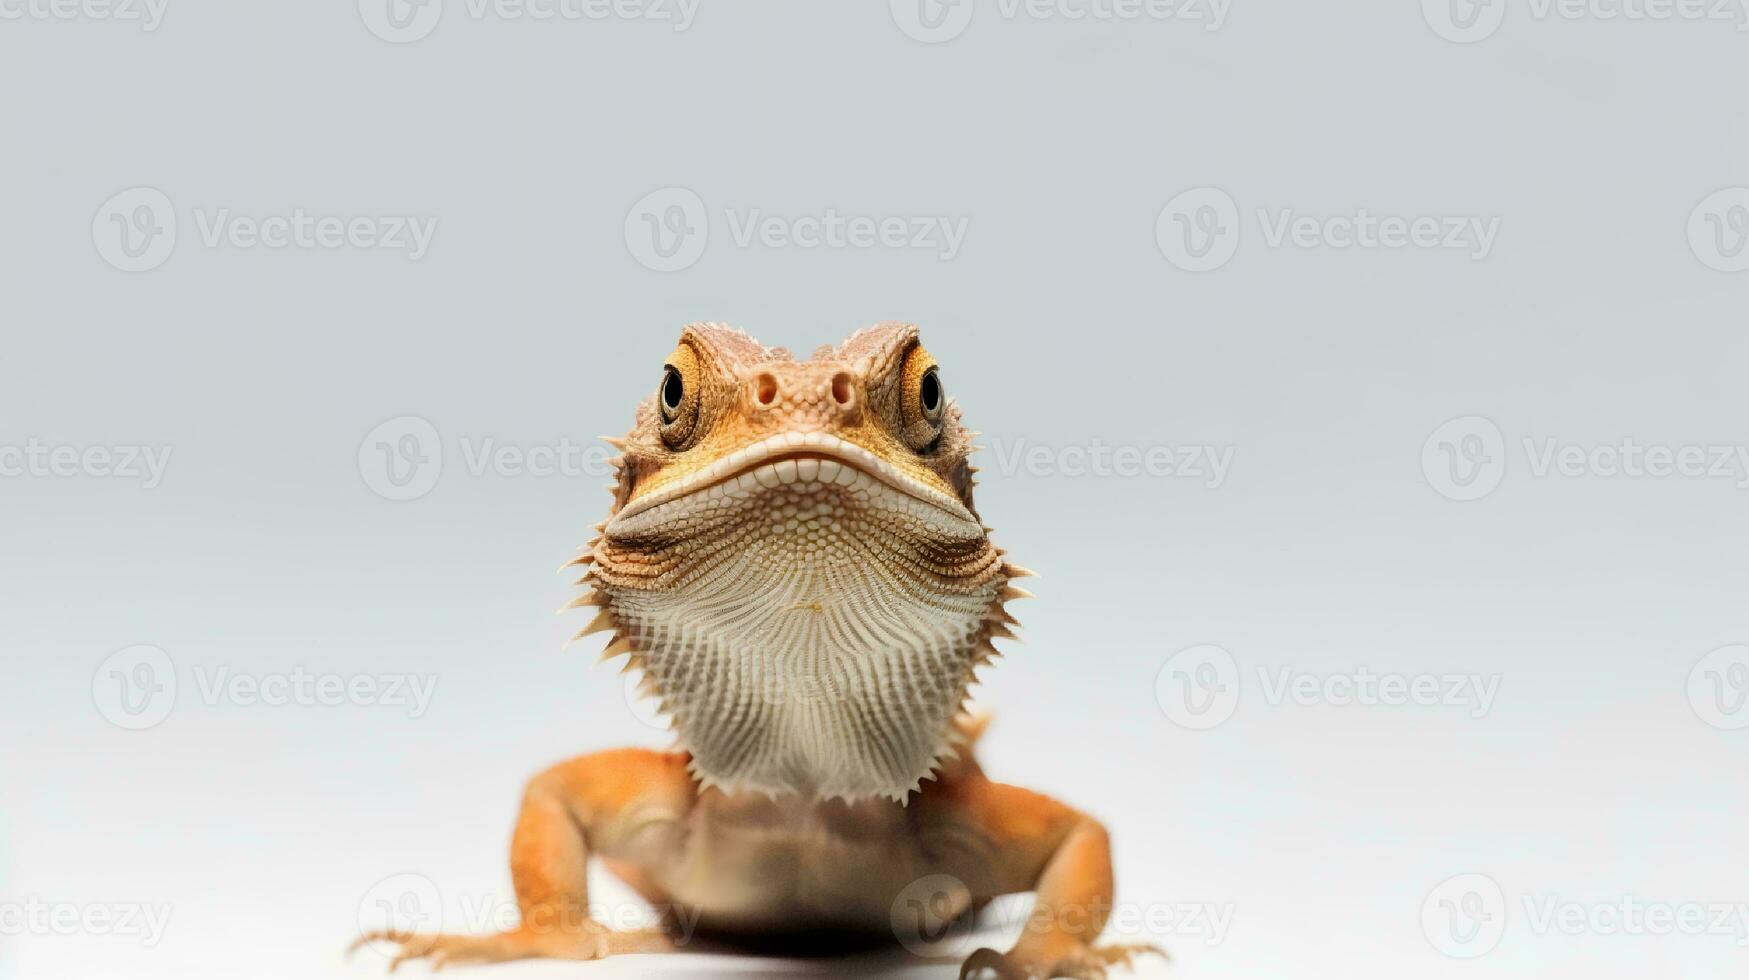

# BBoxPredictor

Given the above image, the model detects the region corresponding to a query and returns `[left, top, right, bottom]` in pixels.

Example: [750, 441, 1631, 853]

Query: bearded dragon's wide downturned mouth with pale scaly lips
[609, 432, 981, 534]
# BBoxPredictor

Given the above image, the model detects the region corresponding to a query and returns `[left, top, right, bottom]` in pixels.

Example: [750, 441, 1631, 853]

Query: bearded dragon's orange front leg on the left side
[353, 749, 694, 970]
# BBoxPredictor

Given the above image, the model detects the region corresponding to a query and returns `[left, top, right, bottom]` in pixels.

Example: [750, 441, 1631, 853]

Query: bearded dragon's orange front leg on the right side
[944, 777, 1167, 980]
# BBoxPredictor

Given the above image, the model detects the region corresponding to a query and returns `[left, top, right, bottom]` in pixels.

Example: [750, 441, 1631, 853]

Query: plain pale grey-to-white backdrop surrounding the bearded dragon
[0, 0, 1749, 980]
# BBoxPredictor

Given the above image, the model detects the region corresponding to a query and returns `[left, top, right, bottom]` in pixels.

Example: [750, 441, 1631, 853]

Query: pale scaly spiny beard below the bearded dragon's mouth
[591, 481, 1011, 800]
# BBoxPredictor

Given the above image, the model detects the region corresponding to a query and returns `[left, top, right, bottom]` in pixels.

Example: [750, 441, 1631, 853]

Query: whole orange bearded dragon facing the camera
[360, 324, 1163, 980]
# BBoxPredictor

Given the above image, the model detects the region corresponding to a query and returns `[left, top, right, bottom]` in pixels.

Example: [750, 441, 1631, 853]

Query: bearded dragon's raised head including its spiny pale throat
[577, 324, 1028, 800]
